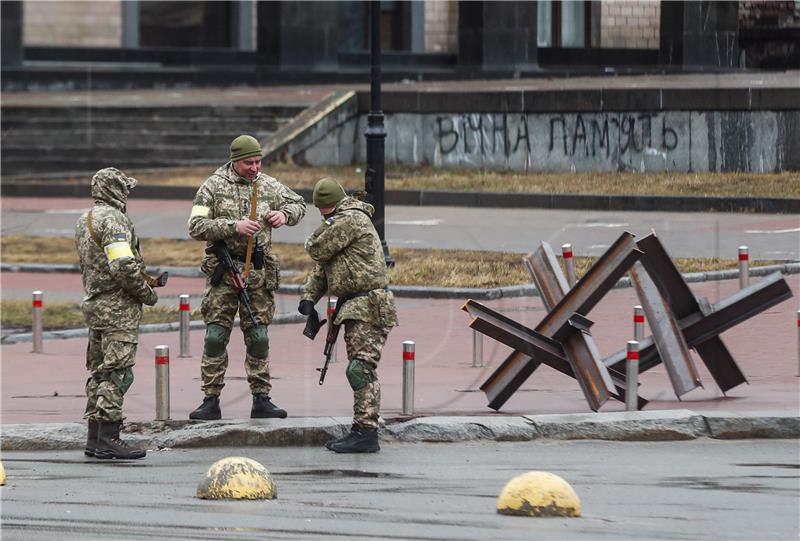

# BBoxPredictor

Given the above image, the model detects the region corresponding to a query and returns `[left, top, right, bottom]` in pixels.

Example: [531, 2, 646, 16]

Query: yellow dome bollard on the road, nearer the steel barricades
[497, 471, 581, 517]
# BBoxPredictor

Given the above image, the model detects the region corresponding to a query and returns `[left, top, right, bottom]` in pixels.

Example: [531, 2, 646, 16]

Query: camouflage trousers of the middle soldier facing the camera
[200, 271, 275, 395]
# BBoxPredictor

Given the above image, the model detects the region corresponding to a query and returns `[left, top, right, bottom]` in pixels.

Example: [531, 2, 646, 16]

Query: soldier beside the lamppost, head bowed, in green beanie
[298, 179, 397, 453]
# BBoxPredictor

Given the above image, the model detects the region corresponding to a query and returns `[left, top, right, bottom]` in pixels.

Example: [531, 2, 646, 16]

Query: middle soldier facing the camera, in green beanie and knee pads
[189, 135, 306, 420]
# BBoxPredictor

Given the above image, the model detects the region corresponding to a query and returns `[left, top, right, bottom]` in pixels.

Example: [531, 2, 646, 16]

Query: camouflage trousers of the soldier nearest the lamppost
[344, 319, 392, 428]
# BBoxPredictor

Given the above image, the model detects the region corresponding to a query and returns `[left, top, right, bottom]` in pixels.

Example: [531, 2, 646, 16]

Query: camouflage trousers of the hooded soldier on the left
[83, 329, 138, 422]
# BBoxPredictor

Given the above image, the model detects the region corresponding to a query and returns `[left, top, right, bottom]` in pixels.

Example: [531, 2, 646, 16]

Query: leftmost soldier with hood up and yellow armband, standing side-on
[75, 167, 158, 458]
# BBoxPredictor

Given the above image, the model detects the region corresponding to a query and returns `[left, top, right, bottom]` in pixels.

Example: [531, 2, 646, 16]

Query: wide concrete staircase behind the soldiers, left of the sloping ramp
[0, 105, 303, 178]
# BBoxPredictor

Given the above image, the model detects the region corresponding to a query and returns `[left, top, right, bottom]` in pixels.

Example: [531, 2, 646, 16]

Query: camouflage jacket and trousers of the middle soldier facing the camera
[189, 162, 306, 396]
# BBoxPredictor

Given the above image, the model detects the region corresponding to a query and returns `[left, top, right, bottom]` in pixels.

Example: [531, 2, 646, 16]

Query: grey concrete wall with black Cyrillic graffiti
[293, 110, 800, 172]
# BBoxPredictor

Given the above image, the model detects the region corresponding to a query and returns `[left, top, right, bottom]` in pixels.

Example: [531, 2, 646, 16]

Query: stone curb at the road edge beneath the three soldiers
[0, 410, 800, 451]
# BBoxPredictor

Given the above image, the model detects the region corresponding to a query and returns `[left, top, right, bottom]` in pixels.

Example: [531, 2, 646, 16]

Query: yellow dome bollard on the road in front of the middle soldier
[197, 456, 278, 500]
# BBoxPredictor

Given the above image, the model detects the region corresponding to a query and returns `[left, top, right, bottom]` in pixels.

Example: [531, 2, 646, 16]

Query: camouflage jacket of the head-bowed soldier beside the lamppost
[302, 197, 397, 327]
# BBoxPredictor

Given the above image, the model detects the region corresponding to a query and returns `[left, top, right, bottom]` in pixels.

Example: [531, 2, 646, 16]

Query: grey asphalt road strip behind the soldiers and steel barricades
[2, 197, 800, 260]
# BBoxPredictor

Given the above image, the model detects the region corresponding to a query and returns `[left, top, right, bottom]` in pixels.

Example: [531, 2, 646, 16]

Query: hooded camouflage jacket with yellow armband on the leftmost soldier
[75, 168, 158, 333]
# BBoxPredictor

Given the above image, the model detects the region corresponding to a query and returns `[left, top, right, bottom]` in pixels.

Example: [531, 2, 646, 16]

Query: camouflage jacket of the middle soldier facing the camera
[189, 162, 306, 288]
